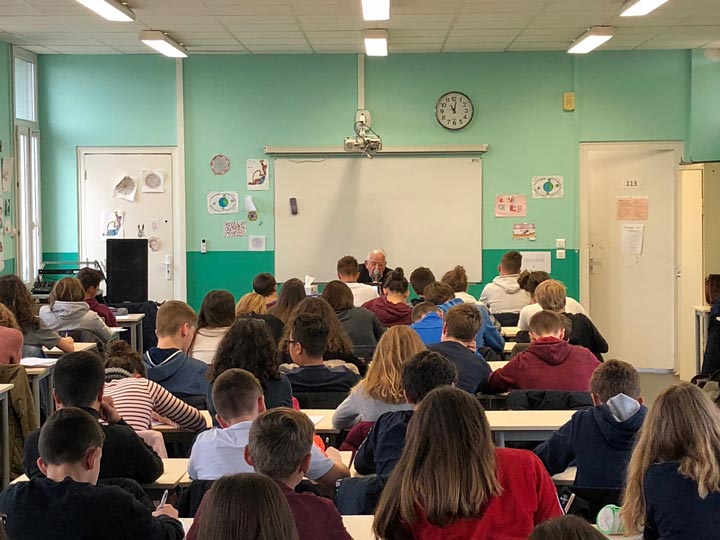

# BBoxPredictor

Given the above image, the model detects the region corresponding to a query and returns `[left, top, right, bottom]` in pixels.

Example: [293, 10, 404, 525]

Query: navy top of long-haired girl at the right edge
[643, 461, 720, 540]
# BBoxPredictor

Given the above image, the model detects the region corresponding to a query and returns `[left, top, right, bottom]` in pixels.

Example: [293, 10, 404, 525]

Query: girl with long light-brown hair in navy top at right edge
[620, 383, 720, 540]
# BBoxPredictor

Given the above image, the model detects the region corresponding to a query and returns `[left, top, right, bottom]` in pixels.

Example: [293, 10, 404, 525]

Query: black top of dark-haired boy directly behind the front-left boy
[24, 407, 163, 484]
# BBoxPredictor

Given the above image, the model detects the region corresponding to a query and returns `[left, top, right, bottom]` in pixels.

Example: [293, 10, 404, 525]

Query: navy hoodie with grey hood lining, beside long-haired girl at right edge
[535, 405, 647, 488]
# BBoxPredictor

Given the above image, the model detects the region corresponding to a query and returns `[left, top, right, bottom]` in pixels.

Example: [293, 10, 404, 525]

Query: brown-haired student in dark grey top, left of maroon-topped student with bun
[321, 280, 385, 359]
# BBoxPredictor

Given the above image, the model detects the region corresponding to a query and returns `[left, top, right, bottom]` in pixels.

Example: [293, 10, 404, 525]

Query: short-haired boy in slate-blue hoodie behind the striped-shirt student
[143, 300, 208, 408]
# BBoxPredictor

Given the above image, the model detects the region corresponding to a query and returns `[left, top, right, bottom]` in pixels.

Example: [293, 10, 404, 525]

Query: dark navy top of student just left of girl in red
[354, 411, 413, 482]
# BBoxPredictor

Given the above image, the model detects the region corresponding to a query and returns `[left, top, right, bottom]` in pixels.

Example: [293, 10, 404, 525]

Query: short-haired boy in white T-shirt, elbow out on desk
[188, 368, 350, 489]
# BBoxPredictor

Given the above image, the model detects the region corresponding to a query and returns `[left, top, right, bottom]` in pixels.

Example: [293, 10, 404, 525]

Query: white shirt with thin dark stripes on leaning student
[105, 377, 205, 431]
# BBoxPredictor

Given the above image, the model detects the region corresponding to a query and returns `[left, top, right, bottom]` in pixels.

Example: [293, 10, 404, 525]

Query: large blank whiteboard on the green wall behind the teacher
[274, 156, 482, 283]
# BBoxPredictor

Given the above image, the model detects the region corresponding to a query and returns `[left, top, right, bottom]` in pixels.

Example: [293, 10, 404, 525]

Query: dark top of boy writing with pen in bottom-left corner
[0, 478, 184, 540]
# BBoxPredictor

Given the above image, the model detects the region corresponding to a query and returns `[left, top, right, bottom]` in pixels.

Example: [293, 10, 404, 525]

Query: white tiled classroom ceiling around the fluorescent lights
[0, 0, 720, 54]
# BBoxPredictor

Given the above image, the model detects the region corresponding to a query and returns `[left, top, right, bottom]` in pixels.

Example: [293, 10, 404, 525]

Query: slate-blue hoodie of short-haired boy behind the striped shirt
[143, 347, 209, 397]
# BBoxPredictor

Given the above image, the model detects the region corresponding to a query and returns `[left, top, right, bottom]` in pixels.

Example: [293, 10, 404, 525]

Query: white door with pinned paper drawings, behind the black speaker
[79, 149, 175, 302]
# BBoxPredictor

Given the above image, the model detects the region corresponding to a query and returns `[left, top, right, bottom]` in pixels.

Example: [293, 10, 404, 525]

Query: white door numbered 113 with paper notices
[581, 143, 682, 370]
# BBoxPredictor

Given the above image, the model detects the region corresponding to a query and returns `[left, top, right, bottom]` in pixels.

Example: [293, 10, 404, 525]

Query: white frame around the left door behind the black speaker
[77, 146, 187, 301]
